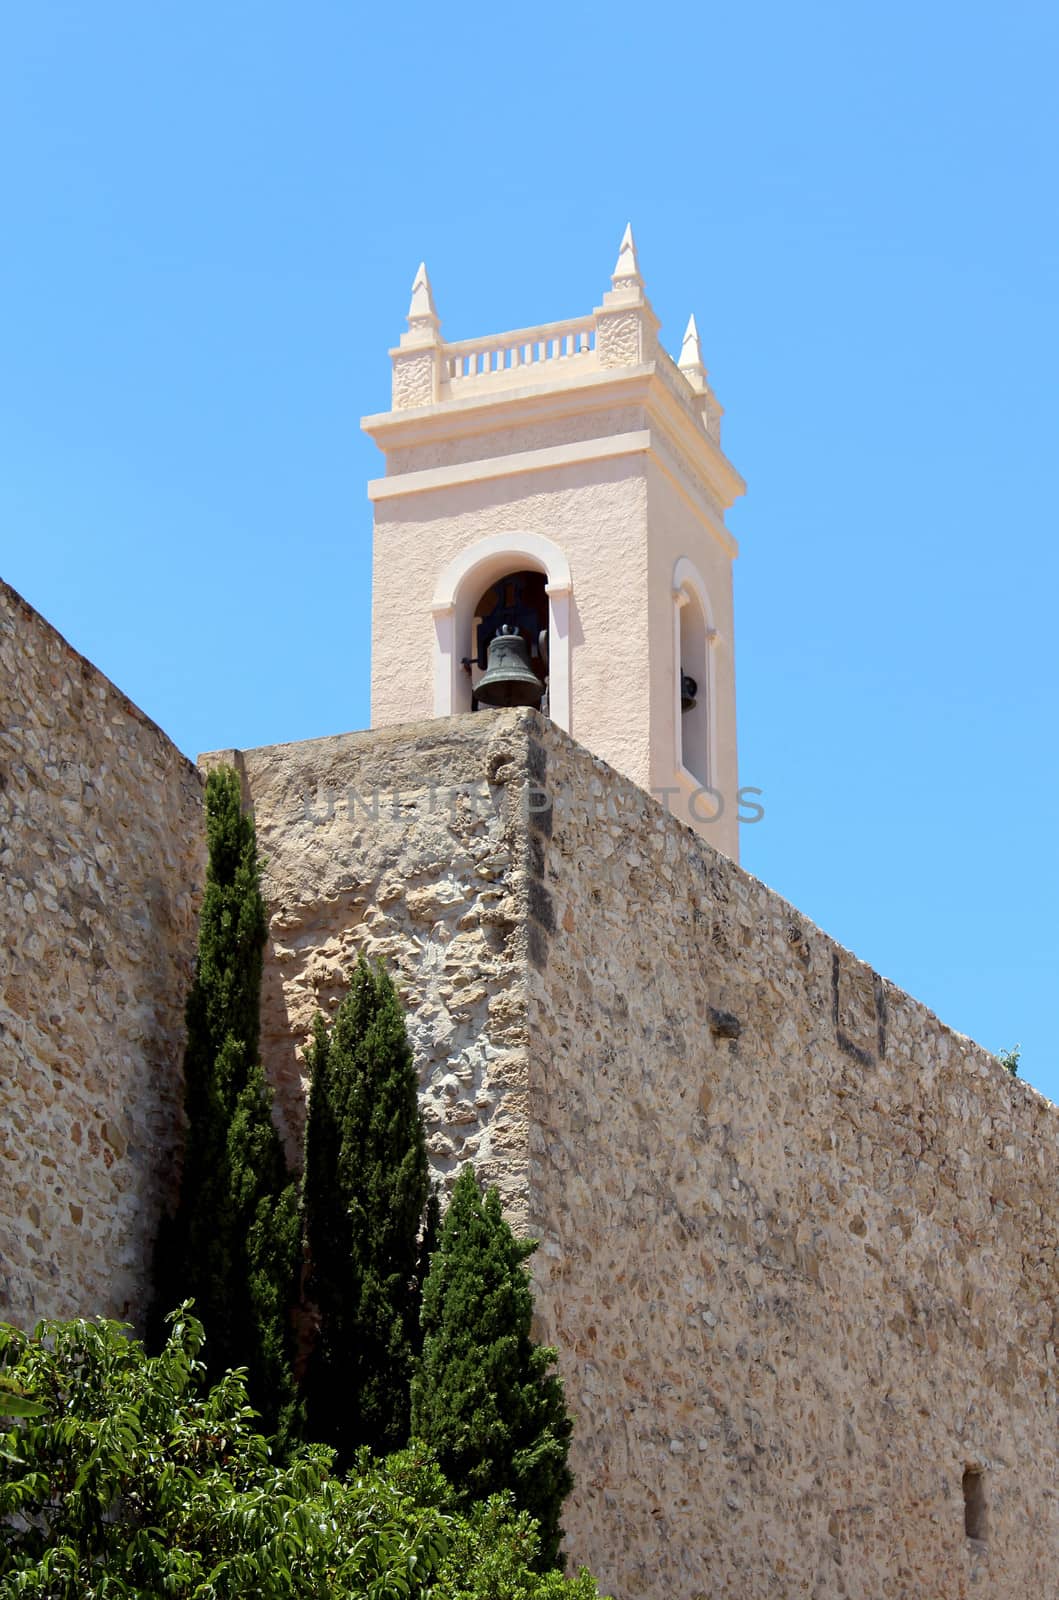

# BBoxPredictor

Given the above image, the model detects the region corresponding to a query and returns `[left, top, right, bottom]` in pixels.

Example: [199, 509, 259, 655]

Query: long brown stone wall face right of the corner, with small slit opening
[528, 728, 1059, 1600]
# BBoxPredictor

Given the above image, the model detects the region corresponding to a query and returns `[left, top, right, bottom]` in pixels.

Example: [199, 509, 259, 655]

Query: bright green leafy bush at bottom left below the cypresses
[0, 1307, 597, 1600]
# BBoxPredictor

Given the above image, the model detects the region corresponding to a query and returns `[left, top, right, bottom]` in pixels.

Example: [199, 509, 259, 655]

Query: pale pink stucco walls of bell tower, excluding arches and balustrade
[370, 374, 739, 859]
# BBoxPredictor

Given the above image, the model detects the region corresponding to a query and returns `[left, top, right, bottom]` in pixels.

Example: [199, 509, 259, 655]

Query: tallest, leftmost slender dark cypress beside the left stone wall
[155, 766, 301, 1434]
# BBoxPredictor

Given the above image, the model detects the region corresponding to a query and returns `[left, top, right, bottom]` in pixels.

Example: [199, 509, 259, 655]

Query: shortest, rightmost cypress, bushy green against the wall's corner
[411, 1166, 573, 1566]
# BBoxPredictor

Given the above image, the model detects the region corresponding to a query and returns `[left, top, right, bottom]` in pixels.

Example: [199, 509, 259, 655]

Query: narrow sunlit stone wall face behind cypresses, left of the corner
[231, 712, 539, 1226]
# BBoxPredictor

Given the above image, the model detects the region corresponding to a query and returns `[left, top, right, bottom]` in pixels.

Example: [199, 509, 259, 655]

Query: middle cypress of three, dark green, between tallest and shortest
[302, 957, 427, 1467]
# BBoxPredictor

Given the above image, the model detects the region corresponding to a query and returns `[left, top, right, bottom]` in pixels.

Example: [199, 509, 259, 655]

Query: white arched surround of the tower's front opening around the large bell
[432, 533, 571, 733]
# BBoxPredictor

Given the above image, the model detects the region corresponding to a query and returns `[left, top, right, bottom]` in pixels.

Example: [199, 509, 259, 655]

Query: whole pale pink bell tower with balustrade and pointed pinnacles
[362, 227, 745, 859]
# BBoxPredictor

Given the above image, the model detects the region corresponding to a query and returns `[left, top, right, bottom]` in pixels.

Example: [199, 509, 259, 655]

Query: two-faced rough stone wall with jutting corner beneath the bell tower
[217, 712, 1059, 1600]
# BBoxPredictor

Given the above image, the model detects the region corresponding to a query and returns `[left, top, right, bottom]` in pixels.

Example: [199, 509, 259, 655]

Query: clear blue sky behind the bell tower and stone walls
[0, 0, 1059, 1098]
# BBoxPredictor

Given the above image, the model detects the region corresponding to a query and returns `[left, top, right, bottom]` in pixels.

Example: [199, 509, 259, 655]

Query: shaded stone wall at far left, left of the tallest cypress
[0, 584, 203, 1326]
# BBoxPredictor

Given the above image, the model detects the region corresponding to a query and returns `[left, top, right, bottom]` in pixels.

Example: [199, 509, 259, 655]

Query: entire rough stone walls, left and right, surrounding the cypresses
[0, 590, 1059, 1600]
